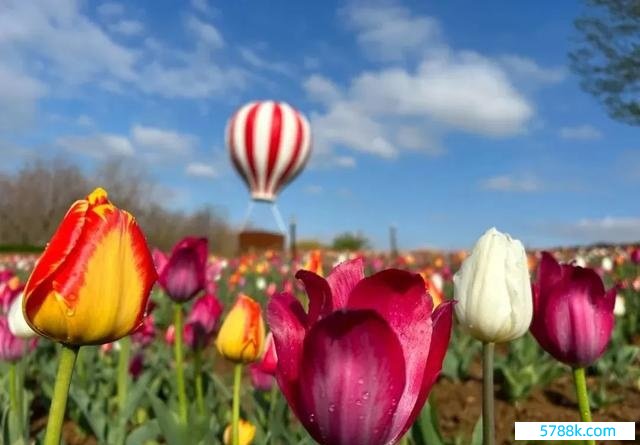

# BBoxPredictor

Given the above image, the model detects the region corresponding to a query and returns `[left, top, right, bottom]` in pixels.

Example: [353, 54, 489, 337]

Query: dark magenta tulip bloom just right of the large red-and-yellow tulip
[155, 237, 209, 303]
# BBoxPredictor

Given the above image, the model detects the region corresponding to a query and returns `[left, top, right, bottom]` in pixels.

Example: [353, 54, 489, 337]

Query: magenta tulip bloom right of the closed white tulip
[531, 252, 616, 368]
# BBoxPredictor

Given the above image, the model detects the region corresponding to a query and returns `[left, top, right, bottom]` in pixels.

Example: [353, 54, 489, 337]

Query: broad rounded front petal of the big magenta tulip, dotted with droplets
[296, 310, 405, 445]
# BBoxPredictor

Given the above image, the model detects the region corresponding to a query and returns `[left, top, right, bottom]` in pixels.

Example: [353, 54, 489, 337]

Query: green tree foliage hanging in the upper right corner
[569, 0, 640, 125]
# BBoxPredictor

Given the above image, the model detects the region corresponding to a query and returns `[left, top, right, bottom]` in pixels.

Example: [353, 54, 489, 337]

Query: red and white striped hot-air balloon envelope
[226, 101, 311, 202]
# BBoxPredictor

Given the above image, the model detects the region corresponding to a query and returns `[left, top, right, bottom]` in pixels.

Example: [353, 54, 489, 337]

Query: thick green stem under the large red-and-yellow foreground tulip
[44, 344, 80, 445]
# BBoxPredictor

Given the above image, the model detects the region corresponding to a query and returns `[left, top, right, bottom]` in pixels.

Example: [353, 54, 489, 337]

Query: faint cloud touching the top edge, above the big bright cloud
[341, 2, 440, 61]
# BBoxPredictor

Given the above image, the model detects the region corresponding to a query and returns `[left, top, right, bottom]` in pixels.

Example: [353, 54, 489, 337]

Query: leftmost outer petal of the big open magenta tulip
[267, 292, 307, 413]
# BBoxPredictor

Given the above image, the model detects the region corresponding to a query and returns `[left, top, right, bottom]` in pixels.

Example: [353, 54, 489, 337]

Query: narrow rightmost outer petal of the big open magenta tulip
[395, 301, 454, 439]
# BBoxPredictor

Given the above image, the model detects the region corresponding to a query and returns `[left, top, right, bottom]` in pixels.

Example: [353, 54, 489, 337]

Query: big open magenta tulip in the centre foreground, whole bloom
[267, 259, 453, 445]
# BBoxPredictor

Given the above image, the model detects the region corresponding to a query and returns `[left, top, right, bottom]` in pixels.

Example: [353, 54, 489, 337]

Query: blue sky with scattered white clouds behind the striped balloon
[0, 0, 640, 248]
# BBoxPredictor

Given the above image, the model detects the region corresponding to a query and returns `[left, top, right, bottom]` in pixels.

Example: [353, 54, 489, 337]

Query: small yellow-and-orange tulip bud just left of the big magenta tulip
[216, 294, 265, 363]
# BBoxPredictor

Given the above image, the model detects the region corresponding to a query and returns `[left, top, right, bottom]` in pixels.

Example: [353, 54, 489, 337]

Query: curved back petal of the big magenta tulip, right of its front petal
[347, 269, 433, 438]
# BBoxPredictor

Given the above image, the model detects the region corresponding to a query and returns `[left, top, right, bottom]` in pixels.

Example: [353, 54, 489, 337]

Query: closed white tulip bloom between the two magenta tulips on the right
[453, 228, 533, 343]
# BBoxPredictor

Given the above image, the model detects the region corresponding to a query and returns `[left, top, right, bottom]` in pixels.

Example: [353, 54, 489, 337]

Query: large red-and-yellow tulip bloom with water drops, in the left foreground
[23, 188, 157, 345]
